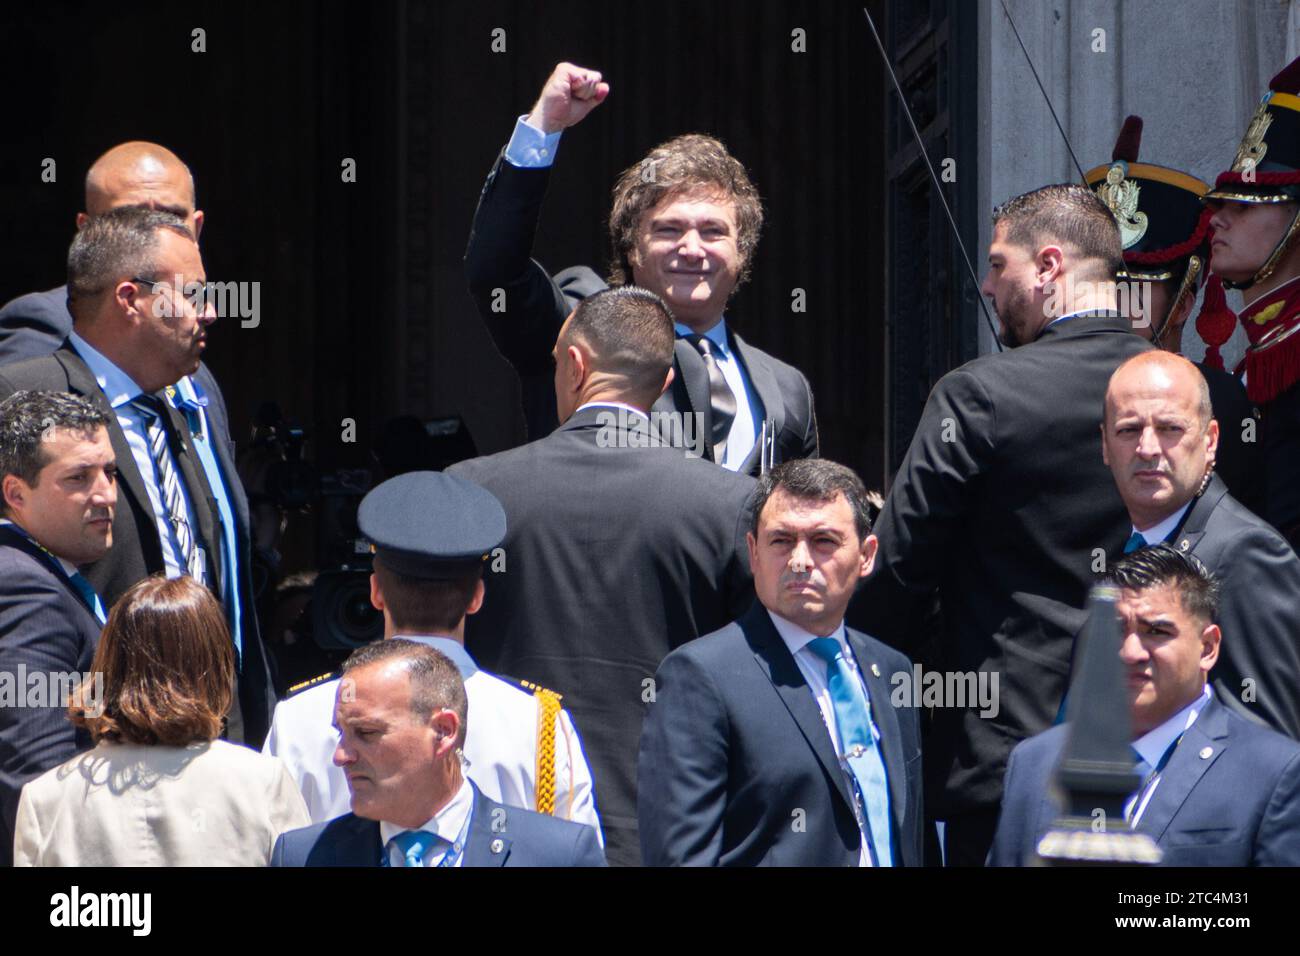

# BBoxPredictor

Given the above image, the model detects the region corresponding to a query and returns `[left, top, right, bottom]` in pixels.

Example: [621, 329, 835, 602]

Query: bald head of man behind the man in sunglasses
[77, 140, 203, 238]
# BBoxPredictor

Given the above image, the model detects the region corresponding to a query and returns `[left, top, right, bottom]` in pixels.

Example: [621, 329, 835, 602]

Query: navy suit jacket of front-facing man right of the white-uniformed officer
[637, 601, 922, 866]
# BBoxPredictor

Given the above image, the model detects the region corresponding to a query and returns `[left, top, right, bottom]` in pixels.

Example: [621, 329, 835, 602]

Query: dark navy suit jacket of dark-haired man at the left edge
[0, 525, 99, 866]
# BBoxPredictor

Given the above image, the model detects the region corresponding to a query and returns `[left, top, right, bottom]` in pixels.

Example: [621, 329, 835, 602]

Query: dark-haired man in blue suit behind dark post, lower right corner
[989, 545, 1300, 866]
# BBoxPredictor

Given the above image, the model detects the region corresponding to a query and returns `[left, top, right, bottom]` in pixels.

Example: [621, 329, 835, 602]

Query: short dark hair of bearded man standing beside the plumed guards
[993, 182, 1125, 282]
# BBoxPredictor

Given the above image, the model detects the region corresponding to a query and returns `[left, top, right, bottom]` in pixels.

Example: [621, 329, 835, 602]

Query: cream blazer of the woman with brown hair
[13, 740, 311, 866]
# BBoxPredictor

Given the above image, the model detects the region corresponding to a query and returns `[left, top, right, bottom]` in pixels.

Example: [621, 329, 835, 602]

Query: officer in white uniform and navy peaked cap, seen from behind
[265, 472, 601, 834]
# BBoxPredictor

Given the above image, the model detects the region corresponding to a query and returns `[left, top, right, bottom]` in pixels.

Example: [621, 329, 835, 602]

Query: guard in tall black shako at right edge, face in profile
[1205, 60, 1300, 548]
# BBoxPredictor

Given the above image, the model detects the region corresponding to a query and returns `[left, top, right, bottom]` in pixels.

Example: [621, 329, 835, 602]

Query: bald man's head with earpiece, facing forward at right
[1101, 349, 1218, 532]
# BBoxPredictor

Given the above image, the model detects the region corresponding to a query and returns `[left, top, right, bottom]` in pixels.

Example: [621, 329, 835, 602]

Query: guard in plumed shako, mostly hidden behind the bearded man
[1084, 116, 1262, 511]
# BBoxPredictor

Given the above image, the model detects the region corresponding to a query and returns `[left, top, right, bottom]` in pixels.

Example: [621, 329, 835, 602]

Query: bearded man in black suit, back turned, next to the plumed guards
[850, 185, 1151, 865]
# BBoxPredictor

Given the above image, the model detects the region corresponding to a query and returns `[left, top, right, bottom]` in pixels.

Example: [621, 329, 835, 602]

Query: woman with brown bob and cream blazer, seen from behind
[14, 576, 311, 866]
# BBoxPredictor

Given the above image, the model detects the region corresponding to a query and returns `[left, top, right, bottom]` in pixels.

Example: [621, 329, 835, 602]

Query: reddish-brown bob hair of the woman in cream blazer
[68, 575, 235, 747]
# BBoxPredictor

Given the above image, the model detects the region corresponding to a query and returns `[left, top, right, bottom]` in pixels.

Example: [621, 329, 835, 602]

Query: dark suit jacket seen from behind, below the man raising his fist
[447, 408, 754, 865]
